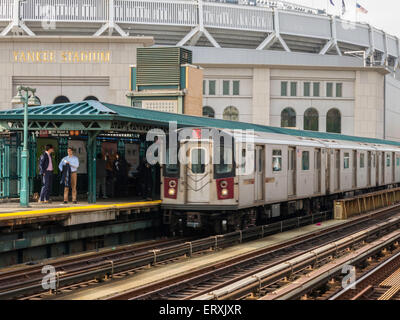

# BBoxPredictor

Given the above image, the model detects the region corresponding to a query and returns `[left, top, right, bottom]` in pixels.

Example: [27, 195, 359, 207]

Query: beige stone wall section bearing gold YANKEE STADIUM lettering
[0, 36, 154, 109]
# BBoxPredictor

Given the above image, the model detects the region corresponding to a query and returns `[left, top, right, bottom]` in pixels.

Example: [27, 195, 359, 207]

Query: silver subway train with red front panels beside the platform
[161, 128, 400, 233]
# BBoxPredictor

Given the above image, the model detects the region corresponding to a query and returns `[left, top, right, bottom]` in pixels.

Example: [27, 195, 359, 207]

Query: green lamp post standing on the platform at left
[11, 86, 40, 207]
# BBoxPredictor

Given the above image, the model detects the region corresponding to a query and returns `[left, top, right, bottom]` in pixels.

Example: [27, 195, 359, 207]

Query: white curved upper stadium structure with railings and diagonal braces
[0, 0, 400, 71]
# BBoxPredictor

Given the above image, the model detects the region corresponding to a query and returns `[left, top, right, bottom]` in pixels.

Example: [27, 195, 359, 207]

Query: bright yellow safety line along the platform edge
[0, 200, 161, 219]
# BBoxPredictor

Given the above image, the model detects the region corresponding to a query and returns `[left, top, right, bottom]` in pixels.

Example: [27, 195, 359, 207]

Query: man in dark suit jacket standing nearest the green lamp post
[39, 144, 54, 203]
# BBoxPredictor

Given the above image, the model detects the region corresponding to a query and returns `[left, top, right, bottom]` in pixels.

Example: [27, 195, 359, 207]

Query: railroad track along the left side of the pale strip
[0, 212, 330, 299]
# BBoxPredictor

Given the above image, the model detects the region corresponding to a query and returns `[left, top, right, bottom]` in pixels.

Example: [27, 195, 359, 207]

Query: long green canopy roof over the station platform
[0, 101, 400, 146]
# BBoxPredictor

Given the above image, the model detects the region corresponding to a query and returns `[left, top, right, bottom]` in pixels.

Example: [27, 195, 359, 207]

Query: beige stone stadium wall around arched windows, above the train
[203, 66, 390, 140]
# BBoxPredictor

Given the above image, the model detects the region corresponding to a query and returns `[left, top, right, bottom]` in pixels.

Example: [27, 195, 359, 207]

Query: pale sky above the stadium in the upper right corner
[286, 0, 400, 37]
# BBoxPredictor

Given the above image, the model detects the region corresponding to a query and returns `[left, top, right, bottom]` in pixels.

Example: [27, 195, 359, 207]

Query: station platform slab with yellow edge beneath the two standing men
[0, 199, 161, 226]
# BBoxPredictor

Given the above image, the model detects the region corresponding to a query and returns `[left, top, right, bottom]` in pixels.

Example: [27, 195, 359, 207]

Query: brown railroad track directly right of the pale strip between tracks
[106, 205, 400, 300]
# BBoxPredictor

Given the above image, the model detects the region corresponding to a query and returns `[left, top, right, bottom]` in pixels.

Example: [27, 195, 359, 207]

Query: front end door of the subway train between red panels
[186, 144, 210, 203]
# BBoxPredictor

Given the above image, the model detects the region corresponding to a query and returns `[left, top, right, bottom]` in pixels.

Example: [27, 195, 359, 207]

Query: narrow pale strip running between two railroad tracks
[53, 220, 346, 300]
